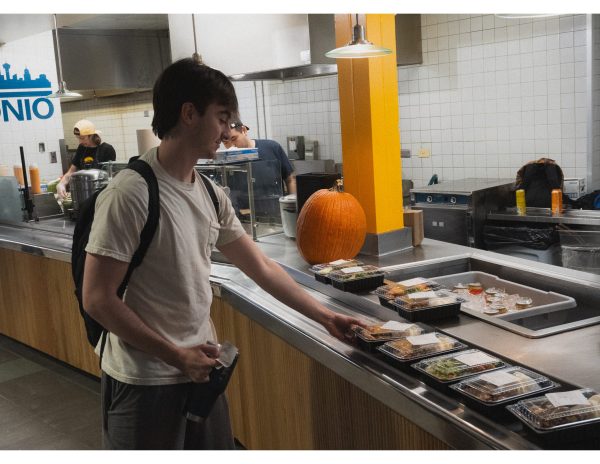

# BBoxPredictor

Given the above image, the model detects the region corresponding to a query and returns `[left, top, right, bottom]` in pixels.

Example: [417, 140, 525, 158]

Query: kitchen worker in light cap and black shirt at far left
[56, 119, 117, 198]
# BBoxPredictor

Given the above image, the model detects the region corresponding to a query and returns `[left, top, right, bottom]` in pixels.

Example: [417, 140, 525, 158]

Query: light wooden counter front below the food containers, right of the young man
[212, 298, 449, 450]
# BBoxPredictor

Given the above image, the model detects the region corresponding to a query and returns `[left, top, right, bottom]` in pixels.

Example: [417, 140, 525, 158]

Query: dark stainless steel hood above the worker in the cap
[54, 28, 171, 98]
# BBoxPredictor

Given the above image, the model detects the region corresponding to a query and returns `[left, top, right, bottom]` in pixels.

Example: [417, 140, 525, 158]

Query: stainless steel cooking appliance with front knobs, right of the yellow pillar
[410, 178, 513, 248]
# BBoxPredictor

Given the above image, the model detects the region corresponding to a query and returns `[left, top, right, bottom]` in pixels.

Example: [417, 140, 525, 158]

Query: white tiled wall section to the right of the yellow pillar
[398, 15, 588, 185]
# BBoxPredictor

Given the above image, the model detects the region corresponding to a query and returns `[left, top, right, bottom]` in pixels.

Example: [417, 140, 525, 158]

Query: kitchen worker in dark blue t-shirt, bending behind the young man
[223, 120, 296, 195]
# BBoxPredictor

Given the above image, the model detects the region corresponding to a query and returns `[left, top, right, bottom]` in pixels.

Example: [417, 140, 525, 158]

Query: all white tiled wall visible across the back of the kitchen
[58, 15, 600, 190]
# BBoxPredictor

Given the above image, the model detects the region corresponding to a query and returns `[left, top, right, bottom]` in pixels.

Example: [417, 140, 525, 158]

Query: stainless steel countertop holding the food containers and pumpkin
[0, 224, 600, 449]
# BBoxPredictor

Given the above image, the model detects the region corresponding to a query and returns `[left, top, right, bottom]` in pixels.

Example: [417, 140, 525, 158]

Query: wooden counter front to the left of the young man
[0, 249, 100, 376]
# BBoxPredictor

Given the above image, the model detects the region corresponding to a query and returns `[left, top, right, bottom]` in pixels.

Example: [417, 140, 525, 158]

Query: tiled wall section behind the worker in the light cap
[62, 91, 154, 161]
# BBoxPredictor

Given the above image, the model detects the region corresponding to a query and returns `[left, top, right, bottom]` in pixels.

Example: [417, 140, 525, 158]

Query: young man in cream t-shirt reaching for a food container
[83, 59, 362, 449]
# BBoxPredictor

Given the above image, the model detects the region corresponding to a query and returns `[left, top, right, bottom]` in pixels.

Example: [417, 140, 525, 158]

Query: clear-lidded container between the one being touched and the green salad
[378, 332, 466, 361]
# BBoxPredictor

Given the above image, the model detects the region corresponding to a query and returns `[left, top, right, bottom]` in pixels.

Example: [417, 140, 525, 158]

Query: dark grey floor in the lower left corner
[0, 335, 102, 450]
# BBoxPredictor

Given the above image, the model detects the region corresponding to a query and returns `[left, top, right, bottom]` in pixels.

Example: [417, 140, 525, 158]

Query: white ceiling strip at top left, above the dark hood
[0, 14, 169, 43]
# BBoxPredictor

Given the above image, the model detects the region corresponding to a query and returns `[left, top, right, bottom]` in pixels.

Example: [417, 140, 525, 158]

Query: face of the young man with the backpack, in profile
[194, 103, 231, 158]
